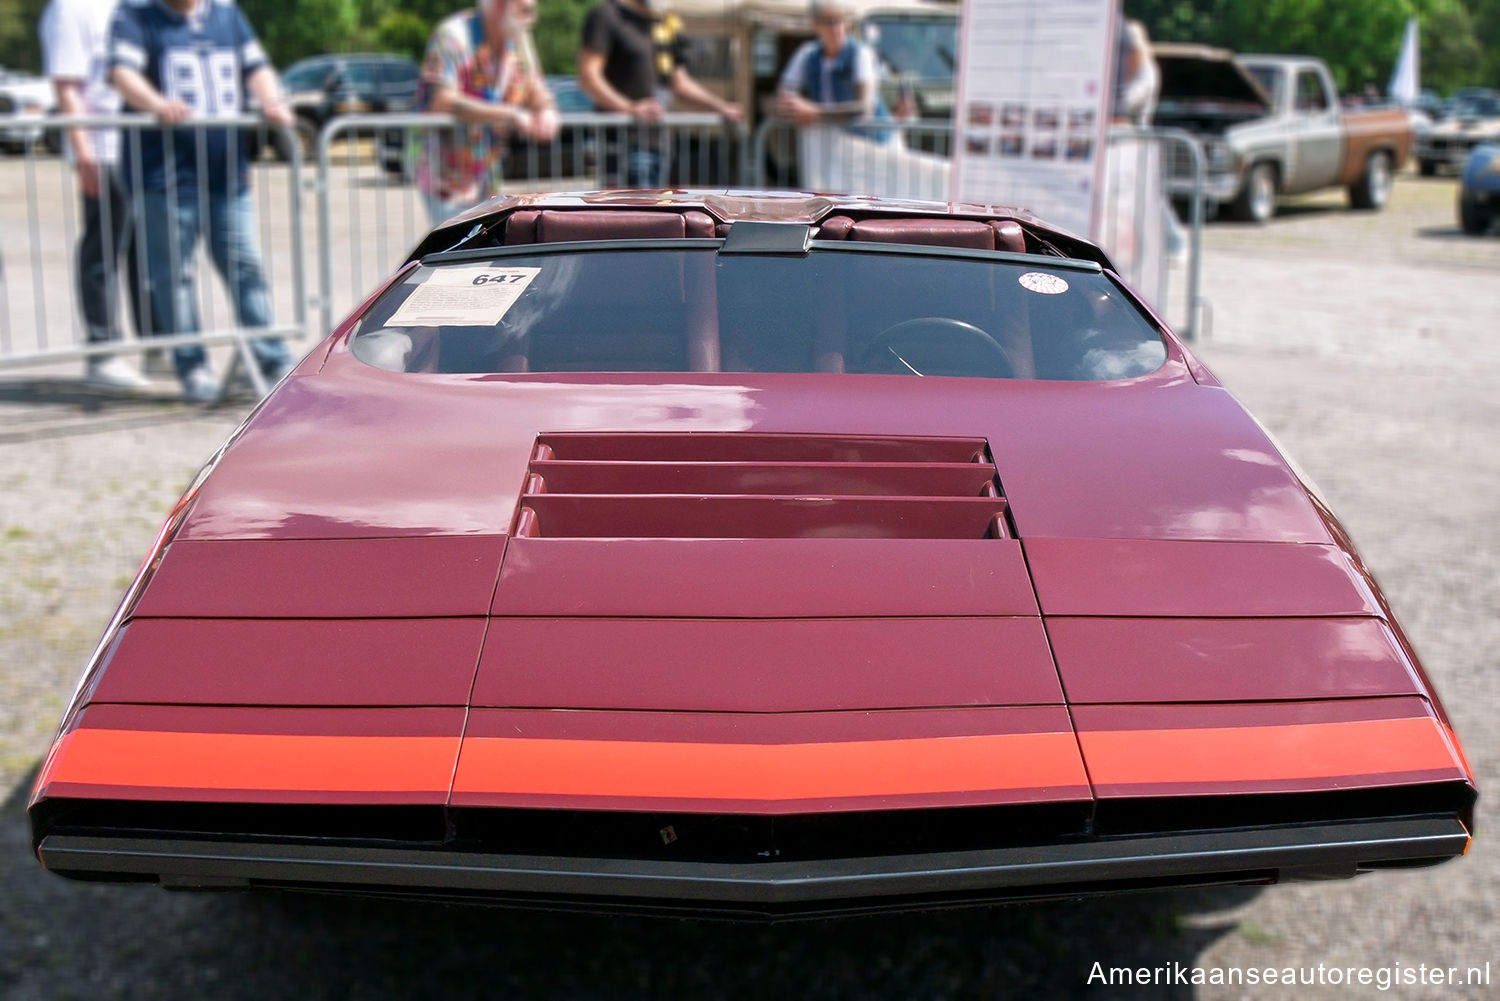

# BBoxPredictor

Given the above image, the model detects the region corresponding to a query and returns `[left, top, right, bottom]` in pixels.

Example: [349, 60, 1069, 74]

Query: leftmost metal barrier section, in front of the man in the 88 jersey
[0, 116, 309, 393]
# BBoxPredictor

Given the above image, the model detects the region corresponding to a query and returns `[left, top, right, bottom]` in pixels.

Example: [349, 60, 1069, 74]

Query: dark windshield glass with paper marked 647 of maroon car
[353, 245, 1167, 380]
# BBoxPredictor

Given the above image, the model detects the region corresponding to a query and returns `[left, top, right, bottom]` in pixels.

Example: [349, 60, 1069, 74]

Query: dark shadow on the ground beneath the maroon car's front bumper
[0, 771, 1259, 1001]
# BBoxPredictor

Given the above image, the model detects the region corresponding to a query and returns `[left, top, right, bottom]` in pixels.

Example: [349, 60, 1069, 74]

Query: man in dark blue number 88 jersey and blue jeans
[108, 0, 294, 402]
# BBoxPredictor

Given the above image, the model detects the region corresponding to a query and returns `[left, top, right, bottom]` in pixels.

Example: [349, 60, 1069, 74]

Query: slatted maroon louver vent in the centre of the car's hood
[516, 432, 1013, 539]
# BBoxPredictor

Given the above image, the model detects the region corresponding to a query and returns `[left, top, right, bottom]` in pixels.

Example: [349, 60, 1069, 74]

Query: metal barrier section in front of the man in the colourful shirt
[317, 113, 744, 330]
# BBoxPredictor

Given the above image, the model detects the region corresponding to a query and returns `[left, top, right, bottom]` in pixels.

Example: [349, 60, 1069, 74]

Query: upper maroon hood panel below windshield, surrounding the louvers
[179, 350, 1332, 545]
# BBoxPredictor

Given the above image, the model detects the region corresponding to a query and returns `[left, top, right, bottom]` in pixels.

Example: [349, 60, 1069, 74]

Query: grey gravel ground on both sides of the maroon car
[0, 177, 1500, 1001]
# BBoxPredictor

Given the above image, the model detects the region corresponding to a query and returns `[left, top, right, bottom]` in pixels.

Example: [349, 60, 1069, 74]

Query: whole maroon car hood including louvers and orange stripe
[38, 350, 1464, 813]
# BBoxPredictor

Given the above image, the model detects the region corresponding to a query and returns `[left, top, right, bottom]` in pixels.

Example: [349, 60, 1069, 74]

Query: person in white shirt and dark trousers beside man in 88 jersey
[39, 0, 147, 390]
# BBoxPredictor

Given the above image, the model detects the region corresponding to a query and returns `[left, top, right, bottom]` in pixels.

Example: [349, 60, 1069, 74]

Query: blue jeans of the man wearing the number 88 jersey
[143, 189, 293, 377]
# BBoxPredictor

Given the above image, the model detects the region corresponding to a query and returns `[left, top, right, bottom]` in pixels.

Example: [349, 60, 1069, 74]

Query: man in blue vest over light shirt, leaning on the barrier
[776, 0, 891, 126]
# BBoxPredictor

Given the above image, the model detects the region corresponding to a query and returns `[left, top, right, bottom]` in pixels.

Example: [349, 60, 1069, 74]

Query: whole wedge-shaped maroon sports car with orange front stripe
[30, 194, 1476, 915]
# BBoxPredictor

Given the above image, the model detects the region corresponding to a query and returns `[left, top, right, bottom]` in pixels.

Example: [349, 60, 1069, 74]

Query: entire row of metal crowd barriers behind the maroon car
[0, 106, 1206, 392]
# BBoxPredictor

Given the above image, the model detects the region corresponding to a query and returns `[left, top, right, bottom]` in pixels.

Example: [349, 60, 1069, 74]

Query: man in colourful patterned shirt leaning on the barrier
[416, 0, 558, 225]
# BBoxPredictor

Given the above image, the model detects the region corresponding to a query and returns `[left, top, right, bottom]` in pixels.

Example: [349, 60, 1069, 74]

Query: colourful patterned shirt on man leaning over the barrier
[414, 11, 546, 201]
